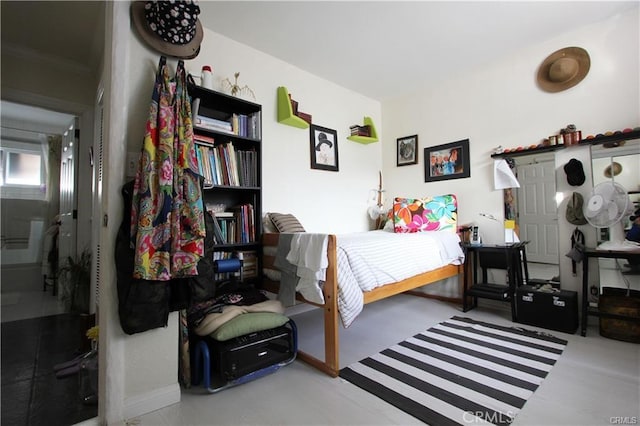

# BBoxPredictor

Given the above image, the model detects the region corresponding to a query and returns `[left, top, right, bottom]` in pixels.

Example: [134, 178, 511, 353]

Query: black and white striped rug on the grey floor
[340, 316, 567, 425]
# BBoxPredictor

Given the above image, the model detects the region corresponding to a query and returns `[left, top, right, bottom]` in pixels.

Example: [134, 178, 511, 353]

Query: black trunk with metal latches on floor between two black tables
[516, 285, 578, 334]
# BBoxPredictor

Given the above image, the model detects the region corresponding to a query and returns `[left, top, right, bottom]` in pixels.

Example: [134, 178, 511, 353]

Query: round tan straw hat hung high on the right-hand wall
[538, 47, 591, 93]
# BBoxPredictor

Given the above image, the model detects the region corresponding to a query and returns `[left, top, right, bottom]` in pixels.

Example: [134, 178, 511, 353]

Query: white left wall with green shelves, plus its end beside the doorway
[101, 8, 382, 421]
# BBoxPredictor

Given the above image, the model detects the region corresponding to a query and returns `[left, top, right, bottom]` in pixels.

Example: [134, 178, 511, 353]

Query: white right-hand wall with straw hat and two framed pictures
[382, 8, 640, 282]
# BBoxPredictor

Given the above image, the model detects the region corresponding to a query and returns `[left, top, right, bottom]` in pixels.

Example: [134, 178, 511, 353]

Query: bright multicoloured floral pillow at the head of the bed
[393, 194, 458, 233]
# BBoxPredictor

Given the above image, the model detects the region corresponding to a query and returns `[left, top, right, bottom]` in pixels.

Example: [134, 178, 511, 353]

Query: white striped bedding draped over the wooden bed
[274, 230, 464, 327]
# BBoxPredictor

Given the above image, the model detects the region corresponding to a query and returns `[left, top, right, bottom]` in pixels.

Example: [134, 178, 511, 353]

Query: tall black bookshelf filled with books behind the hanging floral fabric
[188, 85, 262, 285]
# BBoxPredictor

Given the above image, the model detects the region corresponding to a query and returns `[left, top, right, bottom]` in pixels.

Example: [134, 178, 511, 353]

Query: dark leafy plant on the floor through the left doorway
[59, 249, 91, 314]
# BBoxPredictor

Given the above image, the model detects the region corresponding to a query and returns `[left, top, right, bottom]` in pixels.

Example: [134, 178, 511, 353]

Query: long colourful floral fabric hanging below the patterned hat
[131, 57, 206, 281]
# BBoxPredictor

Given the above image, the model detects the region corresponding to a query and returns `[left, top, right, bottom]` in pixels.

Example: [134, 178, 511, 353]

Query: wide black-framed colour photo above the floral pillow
[424, 139, 471, 182]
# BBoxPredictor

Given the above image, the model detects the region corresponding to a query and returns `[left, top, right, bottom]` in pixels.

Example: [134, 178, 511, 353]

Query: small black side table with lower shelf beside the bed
[462, 241, 529, 321]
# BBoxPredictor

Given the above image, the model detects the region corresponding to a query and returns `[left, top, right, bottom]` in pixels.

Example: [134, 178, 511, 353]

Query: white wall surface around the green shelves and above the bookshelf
[128, 34, 382, 232]
